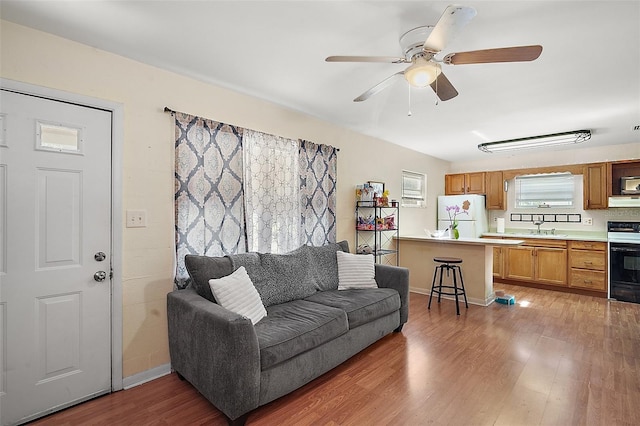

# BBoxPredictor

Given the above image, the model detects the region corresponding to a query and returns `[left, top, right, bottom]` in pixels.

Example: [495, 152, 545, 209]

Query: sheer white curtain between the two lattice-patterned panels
[242, 129, 302, 253]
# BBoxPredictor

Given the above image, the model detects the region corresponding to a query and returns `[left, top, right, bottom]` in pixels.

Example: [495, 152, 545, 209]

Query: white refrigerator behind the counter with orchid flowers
[438, 194, 489, 238]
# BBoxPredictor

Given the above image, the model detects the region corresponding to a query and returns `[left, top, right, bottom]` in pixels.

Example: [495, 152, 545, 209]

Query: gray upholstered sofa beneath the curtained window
[167, 241, 409, 424]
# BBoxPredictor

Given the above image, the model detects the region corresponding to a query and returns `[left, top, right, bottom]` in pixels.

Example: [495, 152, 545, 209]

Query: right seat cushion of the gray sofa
[305, 288, 400, 329]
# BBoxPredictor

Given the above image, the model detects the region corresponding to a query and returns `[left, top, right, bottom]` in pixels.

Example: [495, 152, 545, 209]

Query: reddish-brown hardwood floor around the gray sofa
[34, 284, 640, 426]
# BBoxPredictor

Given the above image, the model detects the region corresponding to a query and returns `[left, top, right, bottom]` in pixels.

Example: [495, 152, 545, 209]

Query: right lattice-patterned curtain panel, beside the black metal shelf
[299, 140, 338, 246]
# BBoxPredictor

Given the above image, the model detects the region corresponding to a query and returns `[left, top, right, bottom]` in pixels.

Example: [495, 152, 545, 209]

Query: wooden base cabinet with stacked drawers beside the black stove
[569, 241, 607, 292]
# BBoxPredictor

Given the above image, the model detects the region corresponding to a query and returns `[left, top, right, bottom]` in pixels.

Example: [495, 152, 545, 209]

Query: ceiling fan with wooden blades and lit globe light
[325, 5, 542, 102]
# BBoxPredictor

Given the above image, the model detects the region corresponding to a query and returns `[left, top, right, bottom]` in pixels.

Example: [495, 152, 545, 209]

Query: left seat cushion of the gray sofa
[255, 300, 349, 370]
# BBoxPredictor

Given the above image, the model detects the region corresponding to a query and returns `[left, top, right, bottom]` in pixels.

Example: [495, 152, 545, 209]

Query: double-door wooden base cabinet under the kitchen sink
[504, 239, 567, 286]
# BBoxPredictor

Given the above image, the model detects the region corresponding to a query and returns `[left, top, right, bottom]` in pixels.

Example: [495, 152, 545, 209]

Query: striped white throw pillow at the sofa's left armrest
[209, 266, 267, 324]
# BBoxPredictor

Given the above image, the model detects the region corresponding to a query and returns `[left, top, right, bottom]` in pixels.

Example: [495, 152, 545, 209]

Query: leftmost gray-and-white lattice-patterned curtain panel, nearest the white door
[174, 113, 246, 288]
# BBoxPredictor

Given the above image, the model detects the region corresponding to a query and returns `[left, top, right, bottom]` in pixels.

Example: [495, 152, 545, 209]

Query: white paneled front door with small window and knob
[0, 90, 111, 425]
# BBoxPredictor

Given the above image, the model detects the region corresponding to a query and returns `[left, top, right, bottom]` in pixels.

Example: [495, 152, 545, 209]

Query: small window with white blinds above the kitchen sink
[515, 173, 575, 208]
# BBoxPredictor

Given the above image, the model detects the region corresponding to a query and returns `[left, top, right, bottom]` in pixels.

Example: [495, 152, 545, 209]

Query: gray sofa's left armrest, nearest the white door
[167, 288, 260, 420]
